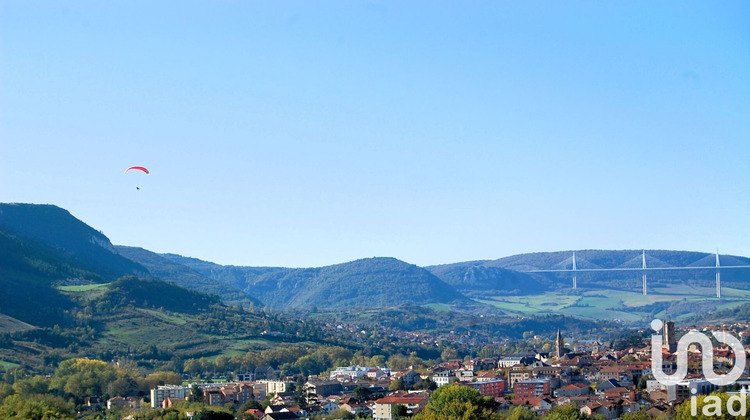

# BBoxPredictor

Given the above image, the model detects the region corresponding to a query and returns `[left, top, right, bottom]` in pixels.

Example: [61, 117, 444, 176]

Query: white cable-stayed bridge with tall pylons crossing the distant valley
[508, 250, 750, 298]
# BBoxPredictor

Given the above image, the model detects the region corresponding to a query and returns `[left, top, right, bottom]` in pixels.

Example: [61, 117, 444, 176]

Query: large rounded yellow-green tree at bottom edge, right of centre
[415, 385, 500, 420]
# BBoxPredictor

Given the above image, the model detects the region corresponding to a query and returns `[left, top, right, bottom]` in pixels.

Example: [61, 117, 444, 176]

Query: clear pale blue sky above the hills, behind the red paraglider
[0, 0, 750, 267]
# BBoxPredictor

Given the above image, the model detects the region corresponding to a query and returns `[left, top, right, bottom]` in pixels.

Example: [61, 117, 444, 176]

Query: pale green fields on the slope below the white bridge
[475, 285, 750, 323]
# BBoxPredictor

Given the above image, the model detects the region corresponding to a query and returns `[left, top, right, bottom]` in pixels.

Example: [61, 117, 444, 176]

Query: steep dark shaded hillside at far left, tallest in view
[0, 203, 153, 328]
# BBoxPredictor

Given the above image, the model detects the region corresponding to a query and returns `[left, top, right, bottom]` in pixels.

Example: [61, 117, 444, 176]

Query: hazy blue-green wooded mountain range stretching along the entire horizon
[0, 204, 750, 318]
